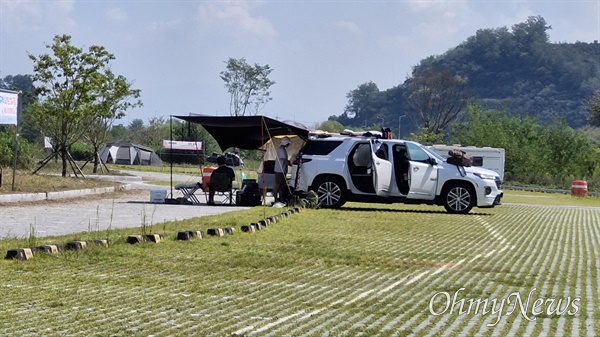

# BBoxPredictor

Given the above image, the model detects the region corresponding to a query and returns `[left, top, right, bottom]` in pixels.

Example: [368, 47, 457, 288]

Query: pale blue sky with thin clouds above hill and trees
[0, 0, 600, 126]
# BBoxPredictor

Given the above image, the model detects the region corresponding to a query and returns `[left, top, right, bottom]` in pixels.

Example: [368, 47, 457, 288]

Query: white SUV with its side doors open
[290, 136, 502, 214]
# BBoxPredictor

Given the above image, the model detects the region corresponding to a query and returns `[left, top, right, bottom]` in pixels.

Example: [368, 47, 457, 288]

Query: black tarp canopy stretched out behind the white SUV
[174, 114, 309, 150]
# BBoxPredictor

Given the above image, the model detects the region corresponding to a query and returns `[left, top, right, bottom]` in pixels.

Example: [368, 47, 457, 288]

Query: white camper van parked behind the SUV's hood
[429, 145, 504, 180]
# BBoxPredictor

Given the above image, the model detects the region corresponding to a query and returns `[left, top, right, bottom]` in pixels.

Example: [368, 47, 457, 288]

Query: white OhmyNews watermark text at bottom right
[429, 288, 581, 327]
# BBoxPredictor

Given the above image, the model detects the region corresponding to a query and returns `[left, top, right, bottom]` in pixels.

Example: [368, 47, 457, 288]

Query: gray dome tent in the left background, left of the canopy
[100, 140, 163, 166]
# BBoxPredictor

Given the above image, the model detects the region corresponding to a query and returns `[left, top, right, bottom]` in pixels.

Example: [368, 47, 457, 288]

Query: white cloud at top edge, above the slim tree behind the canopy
[198, 1, 277, 39]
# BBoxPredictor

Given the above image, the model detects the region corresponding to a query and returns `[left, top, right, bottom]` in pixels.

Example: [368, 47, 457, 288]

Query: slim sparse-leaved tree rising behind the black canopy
[221, 58, 275, 116]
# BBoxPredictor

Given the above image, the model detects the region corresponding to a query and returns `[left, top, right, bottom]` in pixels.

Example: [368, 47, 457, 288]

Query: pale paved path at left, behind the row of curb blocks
[0, 171, 247, 239]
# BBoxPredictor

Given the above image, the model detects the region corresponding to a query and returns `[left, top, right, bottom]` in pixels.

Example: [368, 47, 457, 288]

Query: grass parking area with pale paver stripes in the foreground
[0, 191, 600, 336]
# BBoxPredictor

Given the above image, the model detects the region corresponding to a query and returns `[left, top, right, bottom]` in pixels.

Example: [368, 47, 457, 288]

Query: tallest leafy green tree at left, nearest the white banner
[29, 35, 141, 177]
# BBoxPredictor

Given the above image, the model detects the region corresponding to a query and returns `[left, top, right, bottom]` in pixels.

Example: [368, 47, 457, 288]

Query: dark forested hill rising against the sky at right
[334, 16, 600, 132]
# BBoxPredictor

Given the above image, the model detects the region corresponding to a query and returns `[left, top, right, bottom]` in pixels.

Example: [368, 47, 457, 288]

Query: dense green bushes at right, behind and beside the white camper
[452, 105, 600, 183]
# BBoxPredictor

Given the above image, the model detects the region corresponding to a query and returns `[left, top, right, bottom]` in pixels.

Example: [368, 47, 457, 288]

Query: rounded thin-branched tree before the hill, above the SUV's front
[405, 67, 469, 134]
